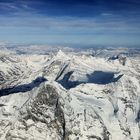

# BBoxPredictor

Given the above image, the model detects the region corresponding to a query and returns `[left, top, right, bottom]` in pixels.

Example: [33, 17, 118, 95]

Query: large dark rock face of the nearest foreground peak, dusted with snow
[27, 85, 65, 139]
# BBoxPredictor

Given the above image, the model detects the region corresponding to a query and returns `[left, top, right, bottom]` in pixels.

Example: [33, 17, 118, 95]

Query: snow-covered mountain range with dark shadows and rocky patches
[0, 49, 140, 140]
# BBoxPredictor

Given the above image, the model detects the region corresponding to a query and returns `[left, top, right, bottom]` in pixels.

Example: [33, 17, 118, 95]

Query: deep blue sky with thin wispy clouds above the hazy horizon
[0, 0, 140, 45]
